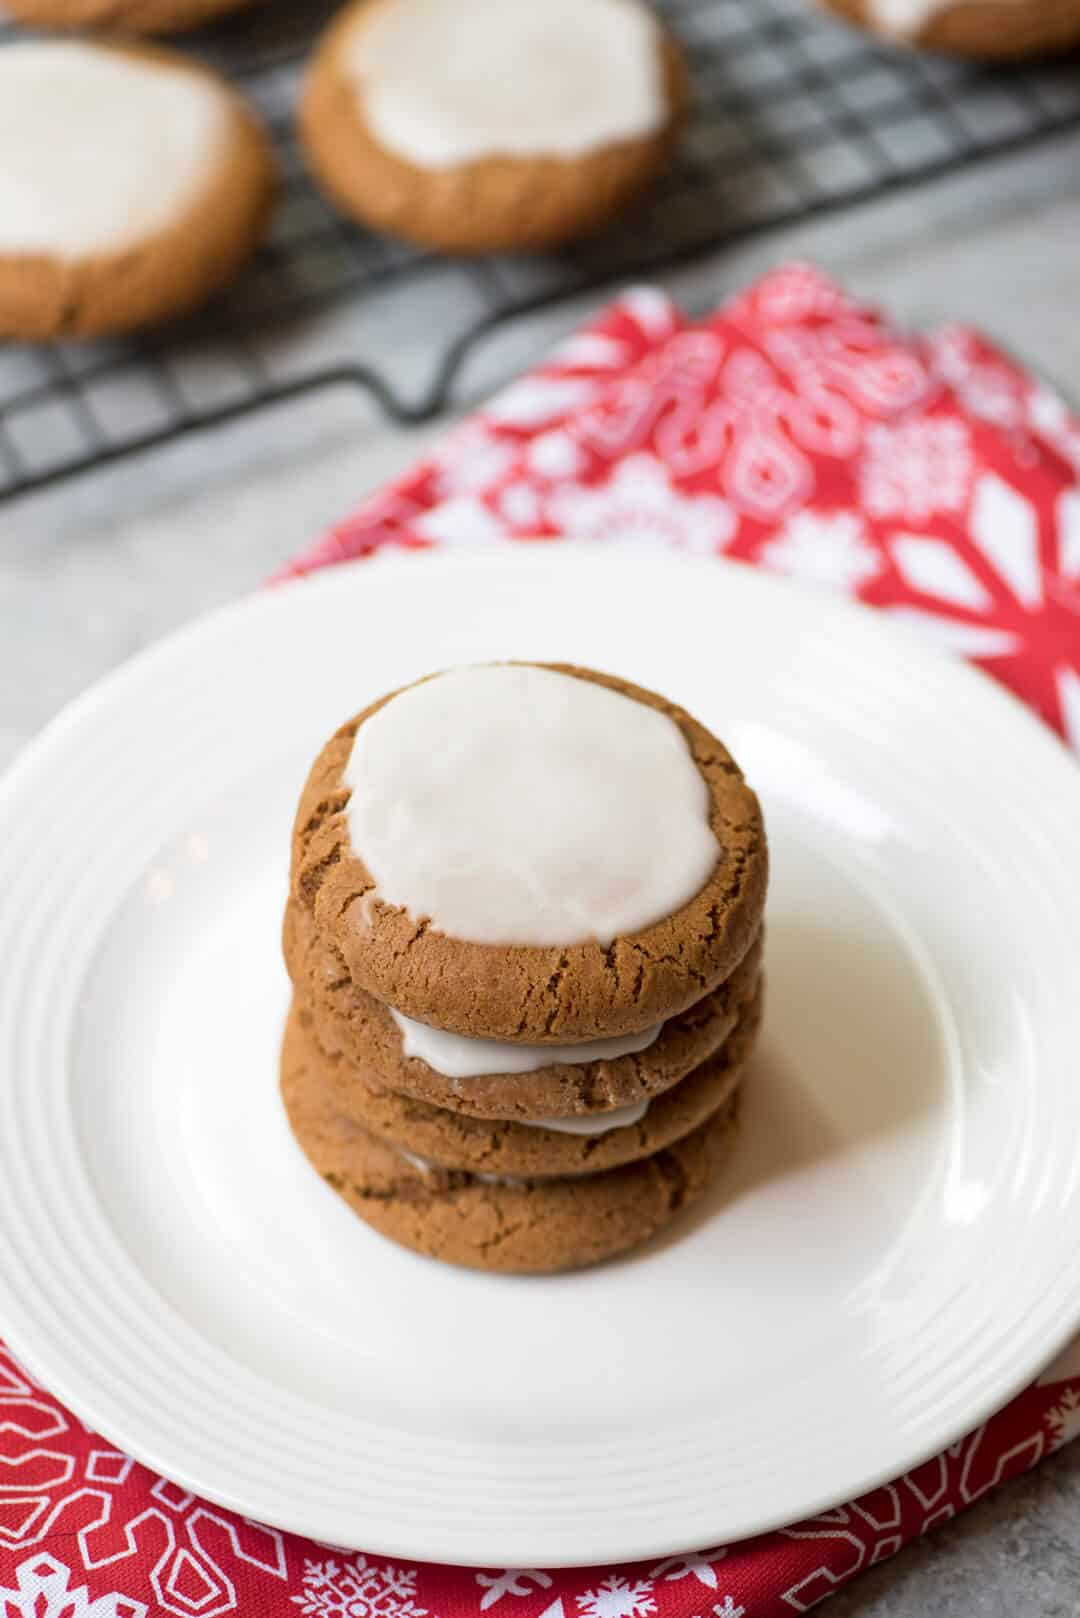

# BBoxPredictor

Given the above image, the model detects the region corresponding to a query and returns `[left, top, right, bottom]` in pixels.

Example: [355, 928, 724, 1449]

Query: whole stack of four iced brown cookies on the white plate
[282, 663, 767, 1272]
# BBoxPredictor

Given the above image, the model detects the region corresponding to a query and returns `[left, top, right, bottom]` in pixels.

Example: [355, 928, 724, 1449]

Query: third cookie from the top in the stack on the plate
[282, 990, 761, 1180]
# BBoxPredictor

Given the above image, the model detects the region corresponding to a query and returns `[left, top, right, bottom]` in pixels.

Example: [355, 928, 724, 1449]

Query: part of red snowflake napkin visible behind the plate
[285, 264, 1080, 748]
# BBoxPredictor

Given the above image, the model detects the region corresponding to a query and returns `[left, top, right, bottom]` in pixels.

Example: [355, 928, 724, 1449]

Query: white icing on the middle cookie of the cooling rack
[342, 0, 667, 168]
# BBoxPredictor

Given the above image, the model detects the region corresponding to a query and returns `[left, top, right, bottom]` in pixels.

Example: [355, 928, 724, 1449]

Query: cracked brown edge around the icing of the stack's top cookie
[290, 663, 767, 1041]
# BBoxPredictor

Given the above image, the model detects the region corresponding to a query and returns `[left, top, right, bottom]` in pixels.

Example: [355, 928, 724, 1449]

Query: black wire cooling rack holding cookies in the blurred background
[0, 0, 1080, 500]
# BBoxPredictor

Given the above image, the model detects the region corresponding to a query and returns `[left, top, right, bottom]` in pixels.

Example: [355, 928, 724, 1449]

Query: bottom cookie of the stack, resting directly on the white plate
[282, 1069, 738, 1275]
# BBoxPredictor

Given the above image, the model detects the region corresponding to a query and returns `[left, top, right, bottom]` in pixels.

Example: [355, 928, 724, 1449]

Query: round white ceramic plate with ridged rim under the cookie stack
[0, 547, 1080, 1566]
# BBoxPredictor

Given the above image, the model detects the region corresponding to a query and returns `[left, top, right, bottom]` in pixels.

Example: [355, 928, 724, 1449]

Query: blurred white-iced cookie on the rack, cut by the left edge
[0, 40, 274, 338]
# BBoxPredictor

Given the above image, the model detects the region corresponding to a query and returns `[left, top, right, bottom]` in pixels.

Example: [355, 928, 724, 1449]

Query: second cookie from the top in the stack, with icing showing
[283, 901, 761, 1118]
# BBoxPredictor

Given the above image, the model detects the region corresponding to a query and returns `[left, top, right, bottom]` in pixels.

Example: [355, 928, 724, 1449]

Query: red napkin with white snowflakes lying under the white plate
[0, 265, 1080, 1618]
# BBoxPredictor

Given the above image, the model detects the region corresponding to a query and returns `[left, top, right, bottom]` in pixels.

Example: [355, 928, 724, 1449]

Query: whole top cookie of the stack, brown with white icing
[291, 663, 767, 1045]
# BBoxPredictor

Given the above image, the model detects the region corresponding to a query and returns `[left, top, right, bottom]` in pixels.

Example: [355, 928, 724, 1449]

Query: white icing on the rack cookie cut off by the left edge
[0, 40, 228, 259]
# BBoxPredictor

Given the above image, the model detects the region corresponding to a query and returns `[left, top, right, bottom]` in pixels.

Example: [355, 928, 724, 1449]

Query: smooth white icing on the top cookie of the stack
[345, 663, 719, 947]
